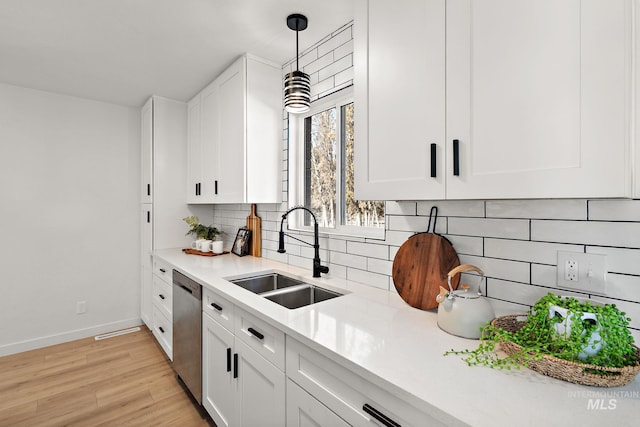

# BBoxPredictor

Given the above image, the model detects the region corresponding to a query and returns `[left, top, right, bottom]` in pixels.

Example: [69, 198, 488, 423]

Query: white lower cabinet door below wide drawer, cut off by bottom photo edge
[287, 379, 349, 427]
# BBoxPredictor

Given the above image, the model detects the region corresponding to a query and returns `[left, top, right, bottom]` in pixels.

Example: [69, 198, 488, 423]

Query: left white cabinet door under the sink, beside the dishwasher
[202, 313, 239, 427]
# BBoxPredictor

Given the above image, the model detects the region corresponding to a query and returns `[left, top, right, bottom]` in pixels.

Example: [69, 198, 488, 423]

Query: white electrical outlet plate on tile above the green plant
[557, 251, 607, 295]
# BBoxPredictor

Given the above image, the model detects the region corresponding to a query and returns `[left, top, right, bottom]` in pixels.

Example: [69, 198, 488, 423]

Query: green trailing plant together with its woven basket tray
[445, 293, 640, 385]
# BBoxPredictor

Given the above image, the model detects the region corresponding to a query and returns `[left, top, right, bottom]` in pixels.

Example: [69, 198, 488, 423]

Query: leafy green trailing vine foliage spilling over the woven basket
[445, 293, 638, 369]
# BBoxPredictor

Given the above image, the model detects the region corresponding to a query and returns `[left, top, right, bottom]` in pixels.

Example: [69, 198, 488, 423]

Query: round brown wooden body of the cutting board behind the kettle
[393, 232, 460, 310]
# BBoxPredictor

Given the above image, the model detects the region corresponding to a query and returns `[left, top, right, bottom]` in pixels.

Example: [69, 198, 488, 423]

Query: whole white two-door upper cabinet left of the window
[187, 55, 282, 203]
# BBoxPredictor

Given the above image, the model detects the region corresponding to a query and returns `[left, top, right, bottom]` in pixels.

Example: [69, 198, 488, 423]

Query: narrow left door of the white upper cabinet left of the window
[187, 95, 202, 203]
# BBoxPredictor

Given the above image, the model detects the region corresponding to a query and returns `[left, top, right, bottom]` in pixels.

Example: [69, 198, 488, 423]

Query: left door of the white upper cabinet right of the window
[354, 0, 445, 200]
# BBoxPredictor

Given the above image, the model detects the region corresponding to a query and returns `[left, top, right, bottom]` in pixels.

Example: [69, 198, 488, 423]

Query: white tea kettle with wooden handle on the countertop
[436, 264, 495, 339]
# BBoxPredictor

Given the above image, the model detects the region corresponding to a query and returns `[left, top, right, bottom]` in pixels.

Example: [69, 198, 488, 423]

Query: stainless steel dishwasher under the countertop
[173, 270, 202, 404]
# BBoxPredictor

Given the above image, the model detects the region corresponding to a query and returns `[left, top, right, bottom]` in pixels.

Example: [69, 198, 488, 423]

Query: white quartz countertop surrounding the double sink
[154, 249, 640, 426]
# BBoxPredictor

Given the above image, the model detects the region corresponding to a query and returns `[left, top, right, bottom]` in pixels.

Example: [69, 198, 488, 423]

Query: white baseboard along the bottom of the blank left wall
[0, 318, 143, 357]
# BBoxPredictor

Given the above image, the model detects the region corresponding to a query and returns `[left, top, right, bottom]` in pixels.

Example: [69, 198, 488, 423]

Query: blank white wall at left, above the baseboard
[0, 84, 140, 355]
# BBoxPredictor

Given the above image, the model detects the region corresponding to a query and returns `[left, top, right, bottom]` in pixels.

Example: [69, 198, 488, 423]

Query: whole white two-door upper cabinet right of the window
[355, 0, 633, 200]
